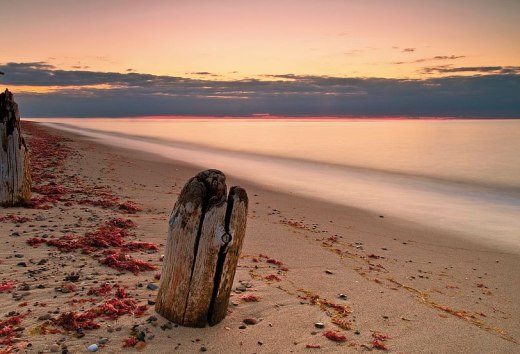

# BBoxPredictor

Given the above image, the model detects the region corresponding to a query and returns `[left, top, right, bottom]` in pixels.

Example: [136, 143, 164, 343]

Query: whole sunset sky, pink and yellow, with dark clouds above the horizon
[0, 0, 520, 118]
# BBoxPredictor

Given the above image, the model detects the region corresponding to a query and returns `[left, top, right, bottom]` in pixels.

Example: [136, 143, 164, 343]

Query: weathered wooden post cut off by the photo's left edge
[0, 90, 31, 206]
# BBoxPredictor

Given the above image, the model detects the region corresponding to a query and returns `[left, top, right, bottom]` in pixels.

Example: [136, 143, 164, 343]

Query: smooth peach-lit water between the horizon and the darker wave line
[27, 119, 520, 188]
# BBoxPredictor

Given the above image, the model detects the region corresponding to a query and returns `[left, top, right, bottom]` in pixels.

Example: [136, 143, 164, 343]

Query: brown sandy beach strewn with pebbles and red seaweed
[0, 122, 520, 353]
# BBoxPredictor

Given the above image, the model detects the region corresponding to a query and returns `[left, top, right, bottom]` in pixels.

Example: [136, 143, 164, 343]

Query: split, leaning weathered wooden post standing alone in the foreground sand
[155, 170, 248, 327]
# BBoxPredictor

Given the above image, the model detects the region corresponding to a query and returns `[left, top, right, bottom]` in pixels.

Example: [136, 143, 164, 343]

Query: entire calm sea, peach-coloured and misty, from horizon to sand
[27, 118, 520, 252]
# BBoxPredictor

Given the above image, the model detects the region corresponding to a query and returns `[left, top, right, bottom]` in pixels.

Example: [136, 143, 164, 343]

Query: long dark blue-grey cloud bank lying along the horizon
[0, 63, 520, 117]
